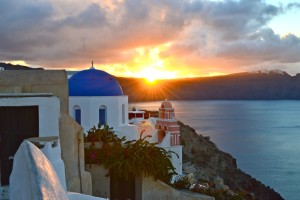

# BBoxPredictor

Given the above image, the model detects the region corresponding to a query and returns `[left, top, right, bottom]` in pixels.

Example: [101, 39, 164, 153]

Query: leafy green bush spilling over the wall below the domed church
[85, 125, 176, 182]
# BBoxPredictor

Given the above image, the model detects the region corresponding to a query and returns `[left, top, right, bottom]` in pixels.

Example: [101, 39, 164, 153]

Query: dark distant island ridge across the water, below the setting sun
[117, 70, 300, 102]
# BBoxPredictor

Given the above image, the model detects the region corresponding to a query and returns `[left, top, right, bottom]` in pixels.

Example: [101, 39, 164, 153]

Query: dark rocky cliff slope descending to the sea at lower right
[179, 122, 283, 200]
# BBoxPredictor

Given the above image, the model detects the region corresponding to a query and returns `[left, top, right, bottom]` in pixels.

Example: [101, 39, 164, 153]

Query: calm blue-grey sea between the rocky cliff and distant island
[130, 101, 300, 200]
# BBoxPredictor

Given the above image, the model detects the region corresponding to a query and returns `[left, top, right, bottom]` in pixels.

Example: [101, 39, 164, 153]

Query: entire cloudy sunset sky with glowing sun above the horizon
[0, 0, 300, 78]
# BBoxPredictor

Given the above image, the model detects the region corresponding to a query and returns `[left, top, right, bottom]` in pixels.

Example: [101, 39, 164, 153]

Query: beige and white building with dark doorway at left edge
[0, 70, 92, 199]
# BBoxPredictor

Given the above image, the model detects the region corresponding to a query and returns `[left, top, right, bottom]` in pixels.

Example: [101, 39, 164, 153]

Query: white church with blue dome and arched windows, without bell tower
[69, 66, 137, 139]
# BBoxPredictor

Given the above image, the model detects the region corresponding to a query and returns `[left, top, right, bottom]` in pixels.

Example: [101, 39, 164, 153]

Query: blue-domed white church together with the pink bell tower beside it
[68, 64, 182, 175]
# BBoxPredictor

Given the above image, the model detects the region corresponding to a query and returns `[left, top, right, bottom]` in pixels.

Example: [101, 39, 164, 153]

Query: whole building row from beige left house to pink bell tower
[0, 66, 182, 199]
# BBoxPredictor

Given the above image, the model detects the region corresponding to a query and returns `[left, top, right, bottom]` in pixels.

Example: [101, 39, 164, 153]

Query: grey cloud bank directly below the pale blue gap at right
[213, 28, 300, 65]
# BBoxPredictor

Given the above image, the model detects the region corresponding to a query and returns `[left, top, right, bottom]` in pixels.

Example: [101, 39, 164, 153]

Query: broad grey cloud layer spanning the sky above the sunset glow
[0, 0, 300, 73]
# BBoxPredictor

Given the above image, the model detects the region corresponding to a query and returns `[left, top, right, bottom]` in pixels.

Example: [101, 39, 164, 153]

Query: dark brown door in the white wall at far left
[0, 106, 39, 185]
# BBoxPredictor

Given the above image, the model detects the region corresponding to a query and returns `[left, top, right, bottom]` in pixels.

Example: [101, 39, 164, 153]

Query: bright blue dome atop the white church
[68, 67, 123, 96]
